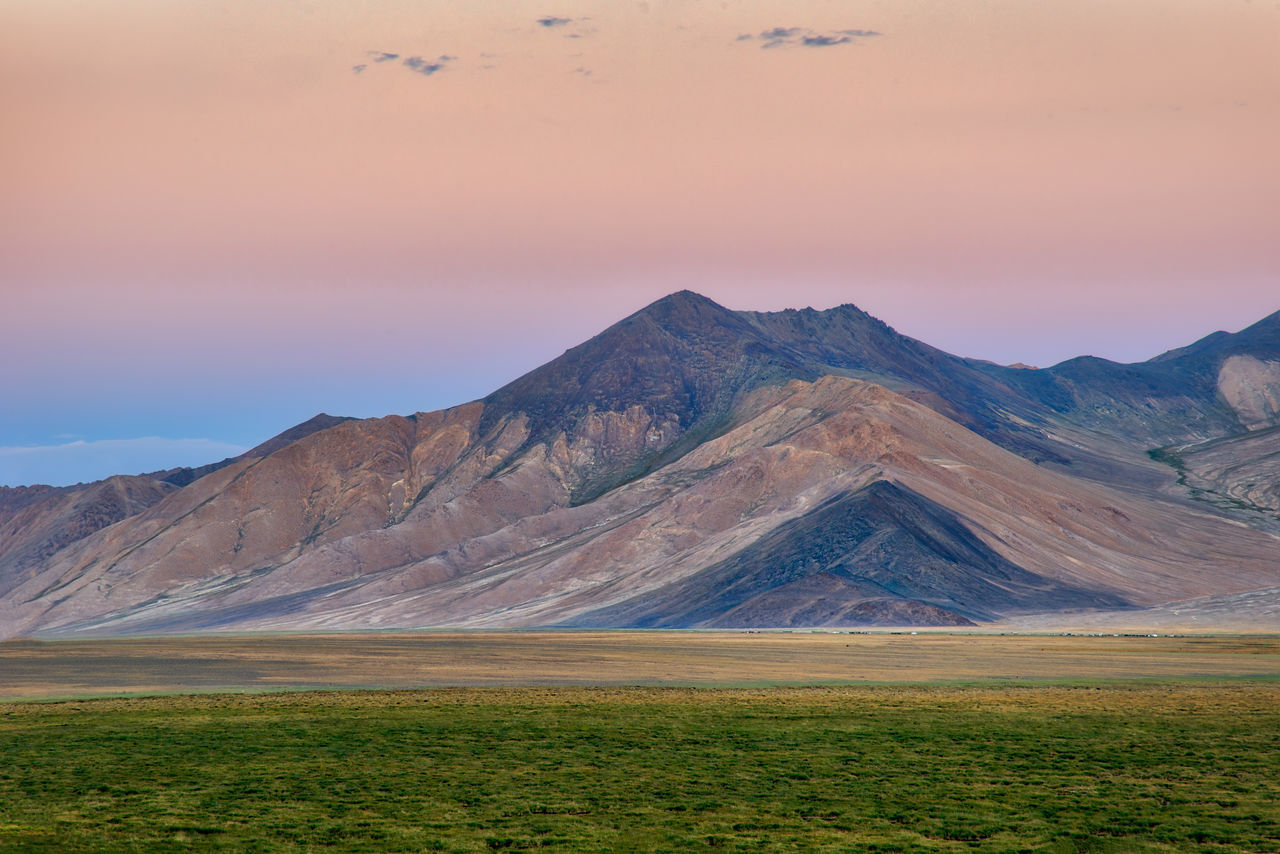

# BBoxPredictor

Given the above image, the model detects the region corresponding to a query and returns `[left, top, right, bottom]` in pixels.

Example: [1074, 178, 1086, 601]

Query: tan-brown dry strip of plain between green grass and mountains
[0, 630, 1280, 700]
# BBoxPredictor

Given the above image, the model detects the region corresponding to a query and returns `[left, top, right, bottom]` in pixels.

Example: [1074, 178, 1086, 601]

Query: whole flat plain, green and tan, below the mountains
[0, 631, 1280, 853]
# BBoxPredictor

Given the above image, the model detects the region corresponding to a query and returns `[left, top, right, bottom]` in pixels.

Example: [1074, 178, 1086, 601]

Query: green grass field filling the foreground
[0, 681, 1280, 851]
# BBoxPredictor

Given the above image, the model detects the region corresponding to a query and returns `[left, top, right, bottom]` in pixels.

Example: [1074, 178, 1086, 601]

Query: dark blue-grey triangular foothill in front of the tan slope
[565, 480, 1128, 627]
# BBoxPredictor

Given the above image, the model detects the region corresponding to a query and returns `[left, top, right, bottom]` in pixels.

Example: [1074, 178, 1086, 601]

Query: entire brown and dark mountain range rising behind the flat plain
[0, 291, 1280, 636]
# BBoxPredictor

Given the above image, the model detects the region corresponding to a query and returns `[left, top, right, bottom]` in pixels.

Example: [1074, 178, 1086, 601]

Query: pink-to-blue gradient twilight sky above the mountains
[0, 0, 1280, 485]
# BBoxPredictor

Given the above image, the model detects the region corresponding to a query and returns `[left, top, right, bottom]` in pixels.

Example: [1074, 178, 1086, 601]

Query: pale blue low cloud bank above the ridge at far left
[0, 437, 248, 487]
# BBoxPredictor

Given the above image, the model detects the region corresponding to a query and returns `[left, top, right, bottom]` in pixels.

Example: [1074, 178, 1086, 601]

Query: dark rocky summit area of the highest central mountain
[481, 291, 1068, 483]
